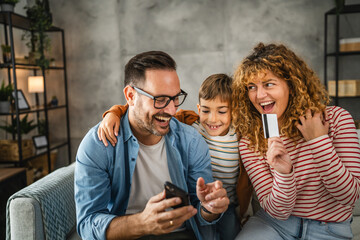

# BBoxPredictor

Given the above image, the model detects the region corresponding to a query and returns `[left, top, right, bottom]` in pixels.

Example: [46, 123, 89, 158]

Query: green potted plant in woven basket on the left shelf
[0, 114, 37, 161]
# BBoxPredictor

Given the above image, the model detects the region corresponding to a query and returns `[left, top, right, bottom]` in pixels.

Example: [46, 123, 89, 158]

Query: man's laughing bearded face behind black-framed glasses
[132, 70, 181, 141]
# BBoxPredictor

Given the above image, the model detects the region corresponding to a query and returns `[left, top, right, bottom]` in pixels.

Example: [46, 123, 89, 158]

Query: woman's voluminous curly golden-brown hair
[232, 43, 329, 156]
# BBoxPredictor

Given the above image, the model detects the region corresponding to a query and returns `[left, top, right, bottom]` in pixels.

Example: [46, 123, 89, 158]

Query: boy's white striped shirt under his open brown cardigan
[192, 121, 239, 204]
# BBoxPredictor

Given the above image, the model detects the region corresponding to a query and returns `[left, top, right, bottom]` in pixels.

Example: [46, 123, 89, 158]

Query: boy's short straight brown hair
[199, 73, 232, 103]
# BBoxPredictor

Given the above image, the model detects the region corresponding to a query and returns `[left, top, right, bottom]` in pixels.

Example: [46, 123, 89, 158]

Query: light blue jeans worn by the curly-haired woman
[236, 209, 353, 240]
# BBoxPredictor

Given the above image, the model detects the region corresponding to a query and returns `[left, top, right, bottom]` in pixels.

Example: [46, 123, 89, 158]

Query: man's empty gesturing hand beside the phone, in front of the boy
[196, 177, 230, 221]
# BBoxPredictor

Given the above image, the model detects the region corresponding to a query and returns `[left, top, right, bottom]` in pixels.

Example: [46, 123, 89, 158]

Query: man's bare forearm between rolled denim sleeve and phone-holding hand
[106, 214, 147, 240]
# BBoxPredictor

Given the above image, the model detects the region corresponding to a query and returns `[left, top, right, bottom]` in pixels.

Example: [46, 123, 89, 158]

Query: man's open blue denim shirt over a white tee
[75, 113, 217, 239]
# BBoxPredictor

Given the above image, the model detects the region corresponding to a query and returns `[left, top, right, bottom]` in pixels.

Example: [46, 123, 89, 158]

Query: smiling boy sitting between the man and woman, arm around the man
[98, 74, 252, 240]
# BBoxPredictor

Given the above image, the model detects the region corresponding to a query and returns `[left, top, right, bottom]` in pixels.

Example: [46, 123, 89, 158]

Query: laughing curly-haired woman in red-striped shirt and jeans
[233, 43, 360, 240]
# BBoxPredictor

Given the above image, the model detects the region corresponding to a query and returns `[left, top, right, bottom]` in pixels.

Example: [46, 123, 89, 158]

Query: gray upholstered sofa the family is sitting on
[6, 164, 360, 240]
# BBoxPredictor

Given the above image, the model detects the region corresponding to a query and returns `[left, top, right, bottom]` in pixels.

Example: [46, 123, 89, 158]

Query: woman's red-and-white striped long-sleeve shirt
[239, 107, 360, 222]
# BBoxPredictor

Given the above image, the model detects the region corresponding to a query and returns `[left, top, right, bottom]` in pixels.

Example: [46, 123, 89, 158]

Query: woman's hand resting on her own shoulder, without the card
[296, 109, 329, 141]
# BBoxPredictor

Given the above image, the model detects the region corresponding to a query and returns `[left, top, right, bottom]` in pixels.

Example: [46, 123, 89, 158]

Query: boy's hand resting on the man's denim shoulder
[97, 112, 120, 147]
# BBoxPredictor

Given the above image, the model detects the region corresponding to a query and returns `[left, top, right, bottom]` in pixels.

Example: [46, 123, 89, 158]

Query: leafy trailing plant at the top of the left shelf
[22, 0, 52, 68]
